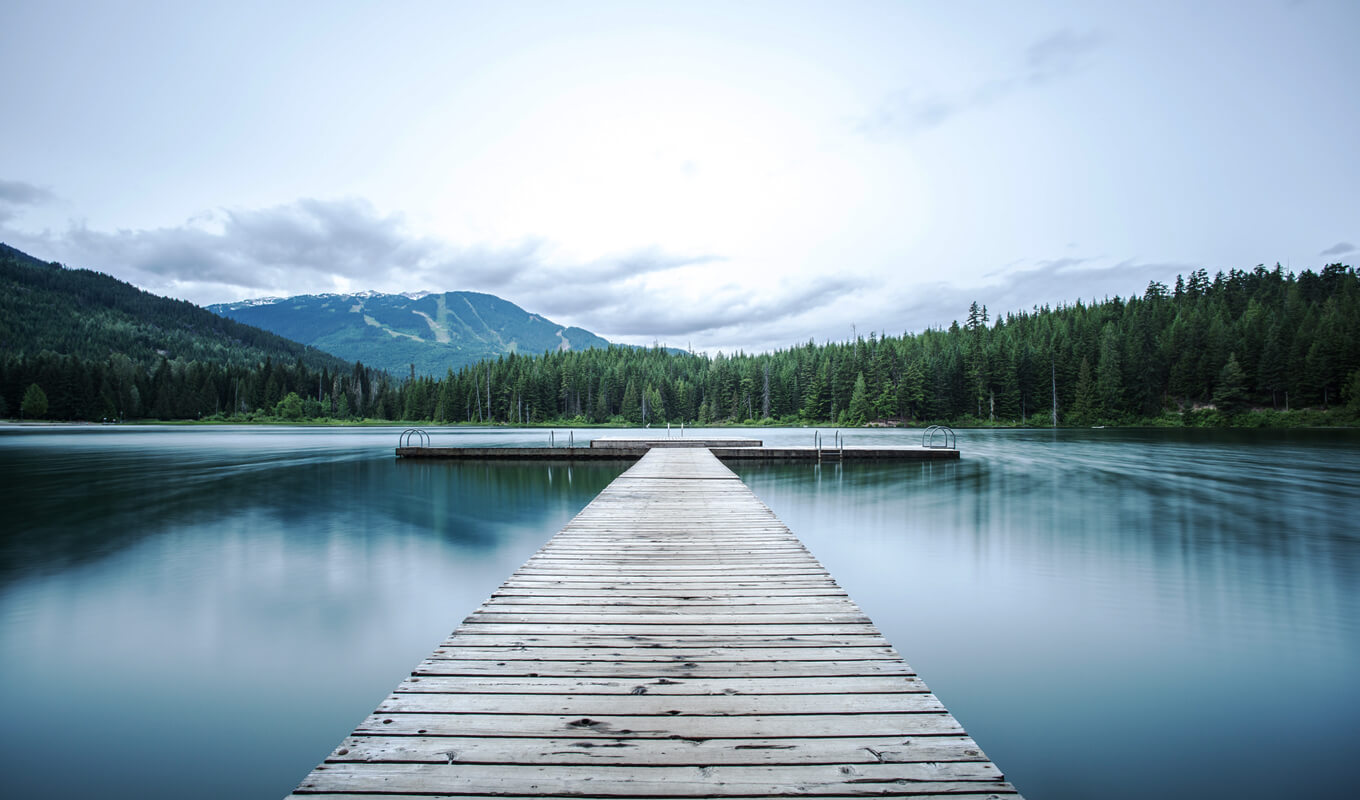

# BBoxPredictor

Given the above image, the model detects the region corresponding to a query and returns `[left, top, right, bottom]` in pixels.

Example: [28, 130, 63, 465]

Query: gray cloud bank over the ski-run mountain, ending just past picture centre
[0, 195, 855, 341]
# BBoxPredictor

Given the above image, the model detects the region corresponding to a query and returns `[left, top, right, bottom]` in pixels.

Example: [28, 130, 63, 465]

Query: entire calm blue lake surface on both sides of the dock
[0, 427, 1360, 800]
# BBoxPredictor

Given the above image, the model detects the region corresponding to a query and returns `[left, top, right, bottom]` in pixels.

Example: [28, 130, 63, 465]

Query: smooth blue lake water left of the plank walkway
[0, 429, 624, 797]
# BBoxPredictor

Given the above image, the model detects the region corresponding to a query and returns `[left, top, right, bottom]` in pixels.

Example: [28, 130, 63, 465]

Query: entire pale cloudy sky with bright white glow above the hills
[0, 0, 1360, 351]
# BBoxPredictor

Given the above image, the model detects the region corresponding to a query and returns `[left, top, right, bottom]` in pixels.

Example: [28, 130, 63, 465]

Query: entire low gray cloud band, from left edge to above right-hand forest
[0, 192, 1224, 351]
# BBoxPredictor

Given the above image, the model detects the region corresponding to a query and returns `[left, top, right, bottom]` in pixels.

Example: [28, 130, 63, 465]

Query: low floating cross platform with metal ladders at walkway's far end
[397, 437, 959, 461]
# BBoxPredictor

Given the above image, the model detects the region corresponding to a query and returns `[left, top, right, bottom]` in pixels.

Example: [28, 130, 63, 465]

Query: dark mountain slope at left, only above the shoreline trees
[0, 244, 352, 371]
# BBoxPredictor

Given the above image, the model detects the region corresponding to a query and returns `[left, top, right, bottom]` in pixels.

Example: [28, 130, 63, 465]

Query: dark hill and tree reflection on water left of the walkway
[0, 449, 627, 581]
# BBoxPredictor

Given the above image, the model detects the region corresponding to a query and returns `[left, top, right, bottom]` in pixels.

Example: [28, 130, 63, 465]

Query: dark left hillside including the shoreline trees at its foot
[0, 245, 397, 419]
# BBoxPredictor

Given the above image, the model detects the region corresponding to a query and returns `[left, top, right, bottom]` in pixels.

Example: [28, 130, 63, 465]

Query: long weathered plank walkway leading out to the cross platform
[295, 448, 1017, 800]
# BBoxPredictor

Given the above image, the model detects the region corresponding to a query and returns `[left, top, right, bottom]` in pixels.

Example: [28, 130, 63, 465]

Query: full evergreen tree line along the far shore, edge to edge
[0, 264, 1360, 426]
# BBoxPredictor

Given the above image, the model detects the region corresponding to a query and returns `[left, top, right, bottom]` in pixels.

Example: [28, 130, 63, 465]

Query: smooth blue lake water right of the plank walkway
[737, 431, 1360, 799]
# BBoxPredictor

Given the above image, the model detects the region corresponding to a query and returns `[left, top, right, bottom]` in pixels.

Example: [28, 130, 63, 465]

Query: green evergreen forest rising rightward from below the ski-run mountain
[403, 264, 1360, 424]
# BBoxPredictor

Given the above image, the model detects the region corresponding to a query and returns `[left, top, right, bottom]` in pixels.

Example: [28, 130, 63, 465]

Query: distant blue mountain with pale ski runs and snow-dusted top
[208, 291, 609, 377]
